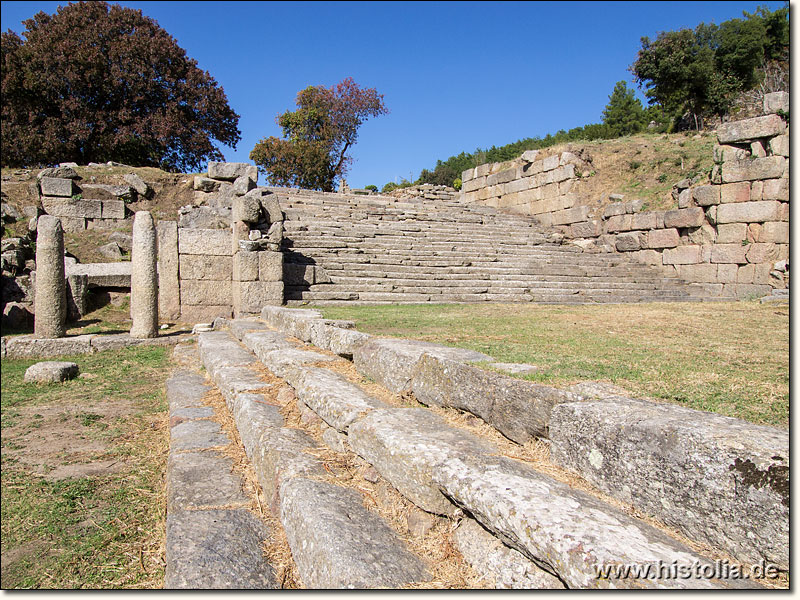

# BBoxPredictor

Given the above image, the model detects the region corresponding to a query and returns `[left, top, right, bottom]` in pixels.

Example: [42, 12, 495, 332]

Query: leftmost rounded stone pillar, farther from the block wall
[33, 215, 67, 338]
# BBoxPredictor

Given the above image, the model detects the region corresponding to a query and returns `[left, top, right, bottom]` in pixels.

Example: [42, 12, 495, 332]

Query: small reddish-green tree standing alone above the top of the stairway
[250, 77, 389, 192]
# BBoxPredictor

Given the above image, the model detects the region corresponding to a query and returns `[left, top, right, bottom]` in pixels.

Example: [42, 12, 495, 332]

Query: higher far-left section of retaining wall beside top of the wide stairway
[461, 150, 589, 225]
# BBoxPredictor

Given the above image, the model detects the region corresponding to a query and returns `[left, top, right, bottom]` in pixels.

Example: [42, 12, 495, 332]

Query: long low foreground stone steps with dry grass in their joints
[166, 316, 776, 589]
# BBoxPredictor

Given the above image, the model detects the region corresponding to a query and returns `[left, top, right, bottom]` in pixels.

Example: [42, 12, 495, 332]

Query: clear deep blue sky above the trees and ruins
[1, 1, 784, 187]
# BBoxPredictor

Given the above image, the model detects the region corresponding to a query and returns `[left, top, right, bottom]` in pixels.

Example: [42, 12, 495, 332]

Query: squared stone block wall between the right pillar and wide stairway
[158, 162, 283, 322]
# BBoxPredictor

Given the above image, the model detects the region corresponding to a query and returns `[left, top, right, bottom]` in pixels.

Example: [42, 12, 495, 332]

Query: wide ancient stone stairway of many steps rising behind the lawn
[273, 188, 719, 305]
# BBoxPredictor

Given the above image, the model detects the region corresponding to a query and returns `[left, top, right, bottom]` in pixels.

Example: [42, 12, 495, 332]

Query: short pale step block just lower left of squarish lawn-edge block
[292, 367, 387, 433]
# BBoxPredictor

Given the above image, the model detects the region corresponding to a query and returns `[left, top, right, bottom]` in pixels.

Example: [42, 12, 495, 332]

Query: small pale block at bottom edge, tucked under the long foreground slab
[452, 517, 565, 590]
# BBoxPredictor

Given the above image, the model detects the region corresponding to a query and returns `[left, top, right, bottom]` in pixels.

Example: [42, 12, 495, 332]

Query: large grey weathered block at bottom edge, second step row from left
[281, 478, 429, 589]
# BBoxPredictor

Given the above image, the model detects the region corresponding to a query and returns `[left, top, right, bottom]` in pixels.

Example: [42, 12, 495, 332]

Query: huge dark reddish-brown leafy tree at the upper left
[0, 2, 240, 171]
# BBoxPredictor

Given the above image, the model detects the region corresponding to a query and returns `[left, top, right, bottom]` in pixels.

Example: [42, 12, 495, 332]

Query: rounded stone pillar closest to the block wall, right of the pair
[131, 210, 158, 338]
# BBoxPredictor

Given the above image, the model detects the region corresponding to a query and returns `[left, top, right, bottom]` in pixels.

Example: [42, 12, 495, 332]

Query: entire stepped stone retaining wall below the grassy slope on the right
[462, 92, 789, 299]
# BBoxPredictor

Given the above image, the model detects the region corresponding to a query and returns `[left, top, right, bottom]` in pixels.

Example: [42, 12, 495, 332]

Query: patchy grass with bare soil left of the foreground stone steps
[0, 347, 171, 589]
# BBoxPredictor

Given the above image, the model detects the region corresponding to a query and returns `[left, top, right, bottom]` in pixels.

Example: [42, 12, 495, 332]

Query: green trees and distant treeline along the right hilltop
[383, 2, 789, 192]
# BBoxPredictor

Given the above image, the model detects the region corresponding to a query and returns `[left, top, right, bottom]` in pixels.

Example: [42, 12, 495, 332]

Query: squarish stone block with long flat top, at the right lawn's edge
[353, 338, 492, 392]
